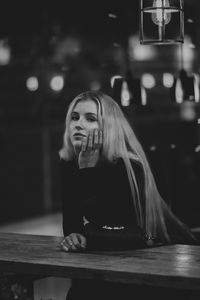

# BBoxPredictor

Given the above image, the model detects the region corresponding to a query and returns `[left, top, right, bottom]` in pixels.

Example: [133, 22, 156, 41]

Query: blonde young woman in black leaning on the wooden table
[60, 91, 195, 299]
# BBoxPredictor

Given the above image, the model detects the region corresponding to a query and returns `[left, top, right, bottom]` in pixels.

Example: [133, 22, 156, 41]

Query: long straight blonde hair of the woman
[60, 91, 195, 242]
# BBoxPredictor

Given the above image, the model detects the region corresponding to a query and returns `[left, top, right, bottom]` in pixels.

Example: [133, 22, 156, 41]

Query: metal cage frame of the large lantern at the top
[139, 0, 184, 45]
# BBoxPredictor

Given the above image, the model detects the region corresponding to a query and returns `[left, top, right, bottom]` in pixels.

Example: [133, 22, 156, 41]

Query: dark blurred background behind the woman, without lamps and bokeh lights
[0, 0, 200, 226]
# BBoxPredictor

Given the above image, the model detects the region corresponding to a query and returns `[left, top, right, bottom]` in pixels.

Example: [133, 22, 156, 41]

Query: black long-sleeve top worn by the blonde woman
[61, 158, 198, 250]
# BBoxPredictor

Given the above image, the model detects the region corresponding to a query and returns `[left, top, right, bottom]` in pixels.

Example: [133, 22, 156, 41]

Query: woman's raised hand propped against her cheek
[78, 129, 103, 169]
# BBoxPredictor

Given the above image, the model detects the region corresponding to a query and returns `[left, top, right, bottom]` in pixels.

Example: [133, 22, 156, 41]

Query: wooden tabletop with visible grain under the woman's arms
[0, 233, 200, 290]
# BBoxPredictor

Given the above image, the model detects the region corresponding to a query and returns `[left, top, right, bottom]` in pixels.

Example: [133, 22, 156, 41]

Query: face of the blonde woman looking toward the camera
[69, 100, 100, 153]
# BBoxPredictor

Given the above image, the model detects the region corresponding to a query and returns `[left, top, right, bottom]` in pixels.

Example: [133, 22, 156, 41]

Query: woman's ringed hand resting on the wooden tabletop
[60, 233, 87, 252]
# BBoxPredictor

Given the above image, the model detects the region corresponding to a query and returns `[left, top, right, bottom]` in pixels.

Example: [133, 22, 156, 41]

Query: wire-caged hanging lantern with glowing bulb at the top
[140, 0, 184, 44]
